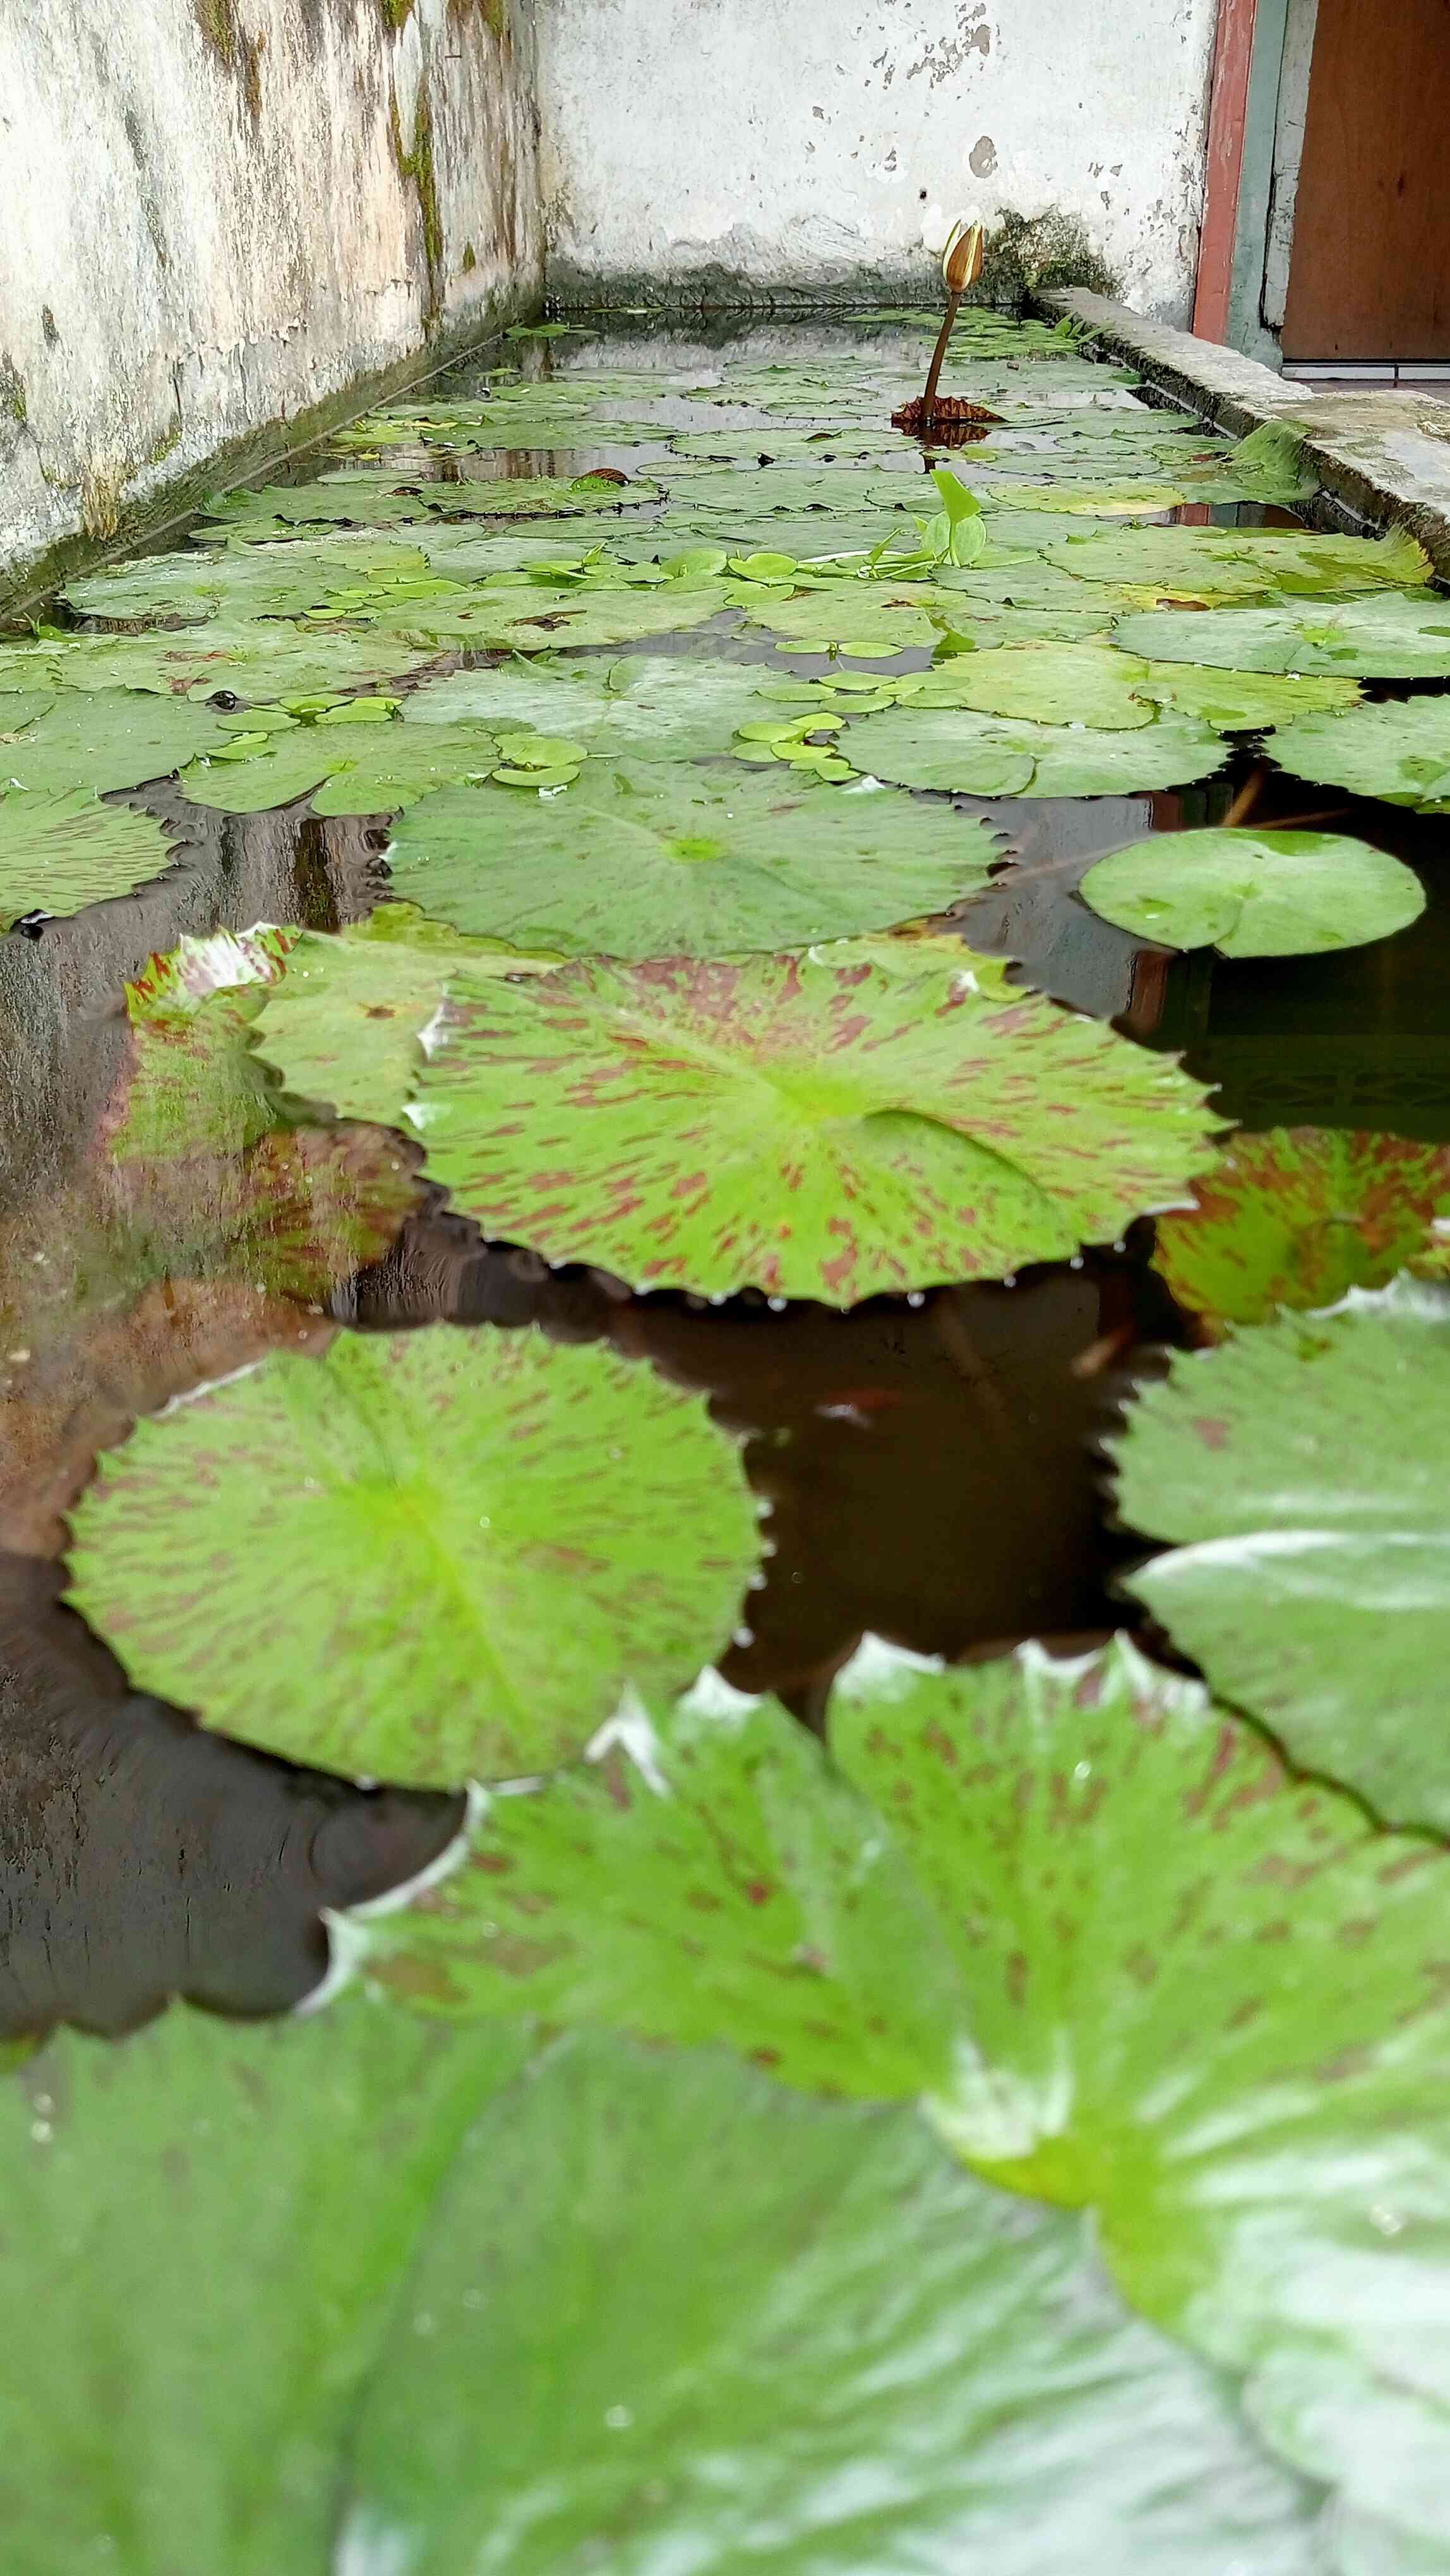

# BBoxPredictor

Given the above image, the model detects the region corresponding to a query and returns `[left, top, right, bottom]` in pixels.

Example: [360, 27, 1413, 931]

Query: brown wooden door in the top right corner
[1283, 0, 1450, 363]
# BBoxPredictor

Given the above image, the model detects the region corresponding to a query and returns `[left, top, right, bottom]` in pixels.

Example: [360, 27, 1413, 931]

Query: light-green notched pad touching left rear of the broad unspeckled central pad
[180, 719, 502, 814]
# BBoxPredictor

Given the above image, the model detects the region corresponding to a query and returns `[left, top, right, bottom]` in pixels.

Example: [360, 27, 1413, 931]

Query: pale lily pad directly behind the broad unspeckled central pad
[404, 654, 782, 760]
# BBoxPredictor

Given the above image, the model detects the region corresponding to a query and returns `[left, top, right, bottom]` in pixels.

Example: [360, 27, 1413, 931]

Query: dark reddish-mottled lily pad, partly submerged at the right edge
[1154, 1128, 1450, 1340]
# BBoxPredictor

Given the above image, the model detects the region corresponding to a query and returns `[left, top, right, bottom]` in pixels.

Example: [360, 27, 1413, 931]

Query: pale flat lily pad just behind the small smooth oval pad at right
[839, 705, 1226, 796]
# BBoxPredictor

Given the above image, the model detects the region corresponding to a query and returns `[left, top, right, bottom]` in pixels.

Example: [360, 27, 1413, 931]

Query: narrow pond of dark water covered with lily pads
[0, 312, 1450, 2576]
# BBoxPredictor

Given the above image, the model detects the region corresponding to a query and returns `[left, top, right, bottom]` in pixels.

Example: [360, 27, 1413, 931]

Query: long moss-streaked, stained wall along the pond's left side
[0, 0, 543, 580]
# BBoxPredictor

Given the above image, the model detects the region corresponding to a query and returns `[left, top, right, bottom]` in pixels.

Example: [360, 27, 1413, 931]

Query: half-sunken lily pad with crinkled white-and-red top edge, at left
[108, 922, 296, 1164]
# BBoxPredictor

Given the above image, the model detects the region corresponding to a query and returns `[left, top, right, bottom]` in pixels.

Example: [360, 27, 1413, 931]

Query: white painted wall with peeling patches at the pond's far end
[538, 0, 1216, 322]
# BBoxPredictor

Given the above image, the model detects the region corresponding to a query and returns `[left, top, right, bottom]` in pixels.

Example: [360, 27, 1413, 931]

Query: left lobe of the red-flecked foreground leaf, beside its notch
[366, 1674, 966, 2102]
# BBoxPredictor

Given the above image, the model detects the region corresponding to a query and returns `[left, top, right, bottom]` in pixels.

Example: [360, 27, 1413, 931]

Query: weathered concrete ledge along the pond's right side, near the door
[1035, 286, 1450, 580]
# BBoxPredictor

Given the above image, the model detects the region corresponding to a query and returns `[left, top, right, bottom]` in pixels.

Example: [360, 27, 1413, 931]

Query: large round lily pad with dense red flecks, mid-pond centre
[420, 943, 1213, 1306]
